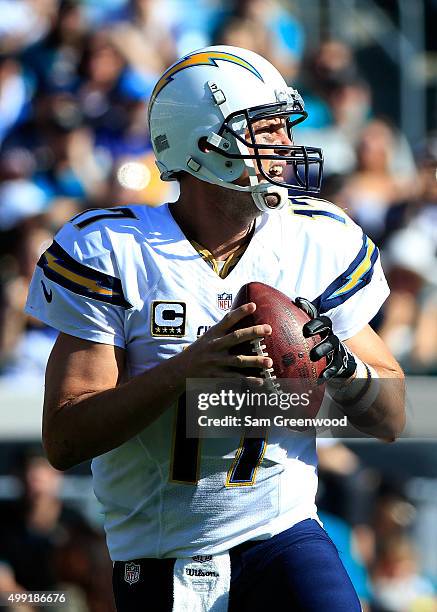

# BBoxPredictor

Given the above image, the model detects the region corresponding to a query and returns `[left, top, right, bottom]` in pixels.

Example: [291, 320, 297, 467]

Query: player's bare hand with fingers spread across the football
[180, 302, 273, 380]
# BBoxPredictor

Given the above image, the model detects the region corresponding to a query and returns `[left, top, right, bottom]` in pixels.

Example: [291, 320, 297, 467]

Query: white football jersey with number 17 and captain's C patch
[26, 197, 388, 561]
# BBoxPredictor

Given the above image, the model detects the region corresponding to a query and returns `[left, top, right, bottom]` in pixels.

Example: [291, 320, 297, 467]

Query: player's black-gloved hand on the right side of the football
[294, 297, 357, 382]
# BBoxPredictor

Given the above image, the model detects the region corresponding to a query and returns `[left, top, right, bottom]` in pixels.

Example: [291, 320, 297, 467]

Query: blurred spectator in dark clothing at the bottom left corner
[0, 448, 114, 612]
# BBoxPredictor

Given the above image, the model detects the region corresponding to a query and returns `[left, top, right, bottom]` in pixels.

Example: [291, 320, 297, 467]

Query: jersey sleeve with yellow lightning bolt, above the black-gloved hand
[314, 226, 390, 340]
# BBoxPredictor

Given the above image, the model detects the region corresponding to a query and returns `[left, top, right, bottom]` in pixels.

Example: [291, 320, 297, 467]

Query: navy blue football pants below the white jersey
[113, 519, 361, 612]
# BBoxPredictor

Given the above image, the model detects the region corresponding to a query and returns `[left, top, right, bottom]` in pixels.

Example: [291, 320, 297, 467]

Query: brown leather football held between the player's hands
[232, 282, 326, 416]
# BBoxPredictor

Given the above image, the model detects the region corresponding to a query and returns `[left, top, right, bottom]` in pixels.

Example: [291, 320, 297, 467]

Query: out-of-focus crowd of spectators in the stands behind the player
[0, 0, 437, 612]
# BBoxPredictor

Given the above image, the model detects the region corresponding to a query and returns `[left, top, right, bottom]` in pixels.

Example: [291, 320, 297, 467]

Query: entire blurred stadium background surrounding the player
[0, 0, 437, 612]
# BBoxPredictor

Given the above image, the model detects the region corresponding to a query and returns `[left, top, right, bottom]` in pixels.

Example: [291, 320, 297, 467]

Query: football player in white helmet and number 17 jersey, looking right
[27, 46, 404, 612]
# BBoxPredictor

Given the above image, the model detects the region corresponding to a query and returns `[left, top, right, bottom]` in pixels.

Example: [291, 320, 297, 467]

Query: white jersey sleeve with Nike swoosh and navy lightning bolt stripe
[25, 214, 130, 348]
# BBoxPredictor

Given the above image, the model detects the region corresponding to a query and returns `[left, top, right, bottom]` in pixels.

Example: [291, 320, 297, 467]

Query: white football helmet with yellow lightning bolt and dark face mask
[148, 46, 323, 211]
